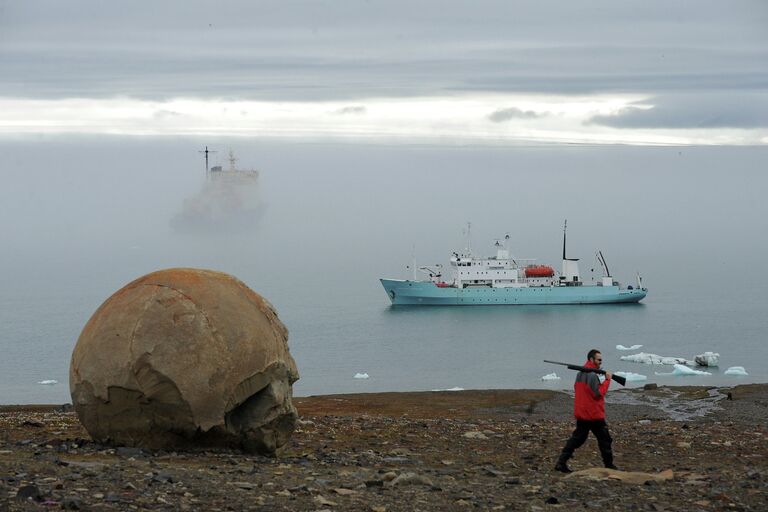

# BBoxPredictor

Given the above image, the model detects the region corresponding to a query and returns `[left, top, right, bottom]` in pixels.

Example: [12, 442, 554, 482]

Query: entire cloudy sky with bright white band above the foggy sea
[0, 0, 768, 145]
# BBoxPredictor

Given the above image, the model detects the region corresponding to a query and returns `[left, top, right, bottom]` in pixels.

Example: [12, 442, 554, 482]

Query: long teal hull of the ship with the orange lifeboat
[381, 279, 647, 306]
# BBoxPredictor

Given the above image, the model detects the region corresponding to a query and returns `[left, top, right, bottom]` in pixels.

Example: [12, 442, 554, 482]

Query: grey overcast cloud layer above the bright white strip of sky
[0, 0, 768, 143]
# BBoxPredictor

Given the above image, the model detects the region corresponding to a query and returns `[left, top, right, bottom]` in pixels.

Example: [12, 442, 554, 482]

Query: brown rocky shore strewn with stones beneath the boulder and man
[0, 384, 768, 512]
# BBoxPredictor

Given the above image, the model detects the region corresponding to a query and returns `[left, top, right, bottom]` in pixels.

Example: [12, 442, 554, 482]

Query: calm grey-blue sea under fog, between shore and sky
[0, 138, 768, 404]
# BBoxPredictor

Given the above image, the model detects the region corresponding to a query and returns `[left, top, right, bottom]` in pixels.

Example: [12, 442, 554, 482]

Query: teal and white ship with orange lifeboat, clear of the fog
[381, 223, 648, 306]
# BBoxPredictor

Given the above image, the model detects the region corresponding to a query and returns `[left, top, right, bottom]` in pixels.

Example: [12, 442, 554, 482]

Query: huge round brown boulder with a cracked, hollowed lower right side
[69, 268, 299, 455]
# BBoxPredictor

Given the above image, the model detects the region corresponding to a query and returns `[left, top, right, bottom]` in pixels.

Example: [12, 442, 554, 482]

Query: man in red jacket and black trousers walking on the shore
[555, 349, 618, 473]
